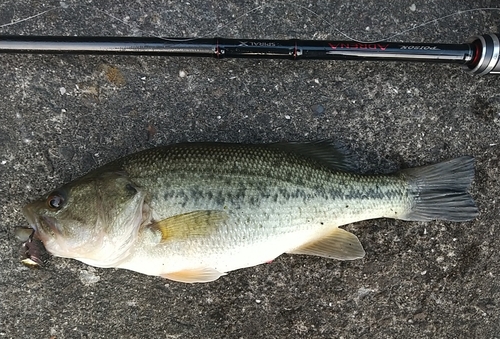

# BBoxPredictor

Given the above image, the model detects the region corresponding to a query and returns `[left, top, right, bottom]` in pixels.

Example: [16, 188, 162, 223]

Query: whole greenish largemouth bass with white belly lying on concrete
[23, 140, 478, 283]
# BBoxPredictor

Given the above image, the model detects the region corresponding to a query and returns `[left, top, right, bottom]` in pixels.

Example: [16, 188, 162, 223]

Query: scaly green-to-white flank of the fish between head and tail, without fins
[113, 145, 407, 272]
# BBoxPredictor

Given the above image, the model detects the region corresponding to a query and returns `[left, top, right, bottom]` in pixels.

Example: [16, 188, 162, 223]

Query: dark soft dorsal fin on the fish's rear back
[268, 140, 356, 172]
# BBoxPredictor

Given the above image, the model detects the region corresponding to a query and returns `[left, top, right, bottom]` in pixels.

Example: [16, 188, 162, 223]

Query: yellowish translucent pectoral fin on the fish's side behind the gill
[150, 210, 227, 242]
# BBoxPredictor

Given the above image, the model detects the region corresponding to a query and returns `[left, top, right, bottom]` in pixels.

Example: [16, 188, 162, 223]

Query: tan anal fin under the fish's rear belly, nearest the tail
[288, 228, 365, 260]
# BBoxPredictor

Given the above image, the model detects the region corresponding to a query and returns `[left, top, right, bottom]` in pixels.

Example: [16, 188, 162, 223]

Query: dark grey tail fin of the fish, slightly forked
[400, 156, 477, 221]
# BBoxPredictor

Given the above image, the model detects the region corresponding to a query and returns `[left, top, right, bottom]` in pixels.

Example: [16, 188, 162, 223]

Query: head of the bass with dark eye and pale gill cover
[23, 172, 147, 267]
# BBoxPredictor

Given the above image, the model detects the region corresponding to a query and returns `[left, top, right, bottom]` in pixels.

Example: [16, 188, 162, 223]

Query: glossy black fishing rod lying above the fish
[0, 34, 500, 75]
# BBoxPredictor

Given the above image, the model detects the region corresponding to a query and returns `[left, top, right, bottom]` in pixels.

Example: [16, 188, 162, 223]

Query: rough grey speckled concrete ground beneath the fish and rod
[0, 0, 500, 339]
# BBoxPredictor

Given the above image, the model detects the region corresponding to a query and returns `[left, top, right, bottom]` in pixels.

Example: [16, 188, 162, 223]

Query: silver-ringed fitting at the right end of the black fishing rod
[465, 33, 500, 75]
